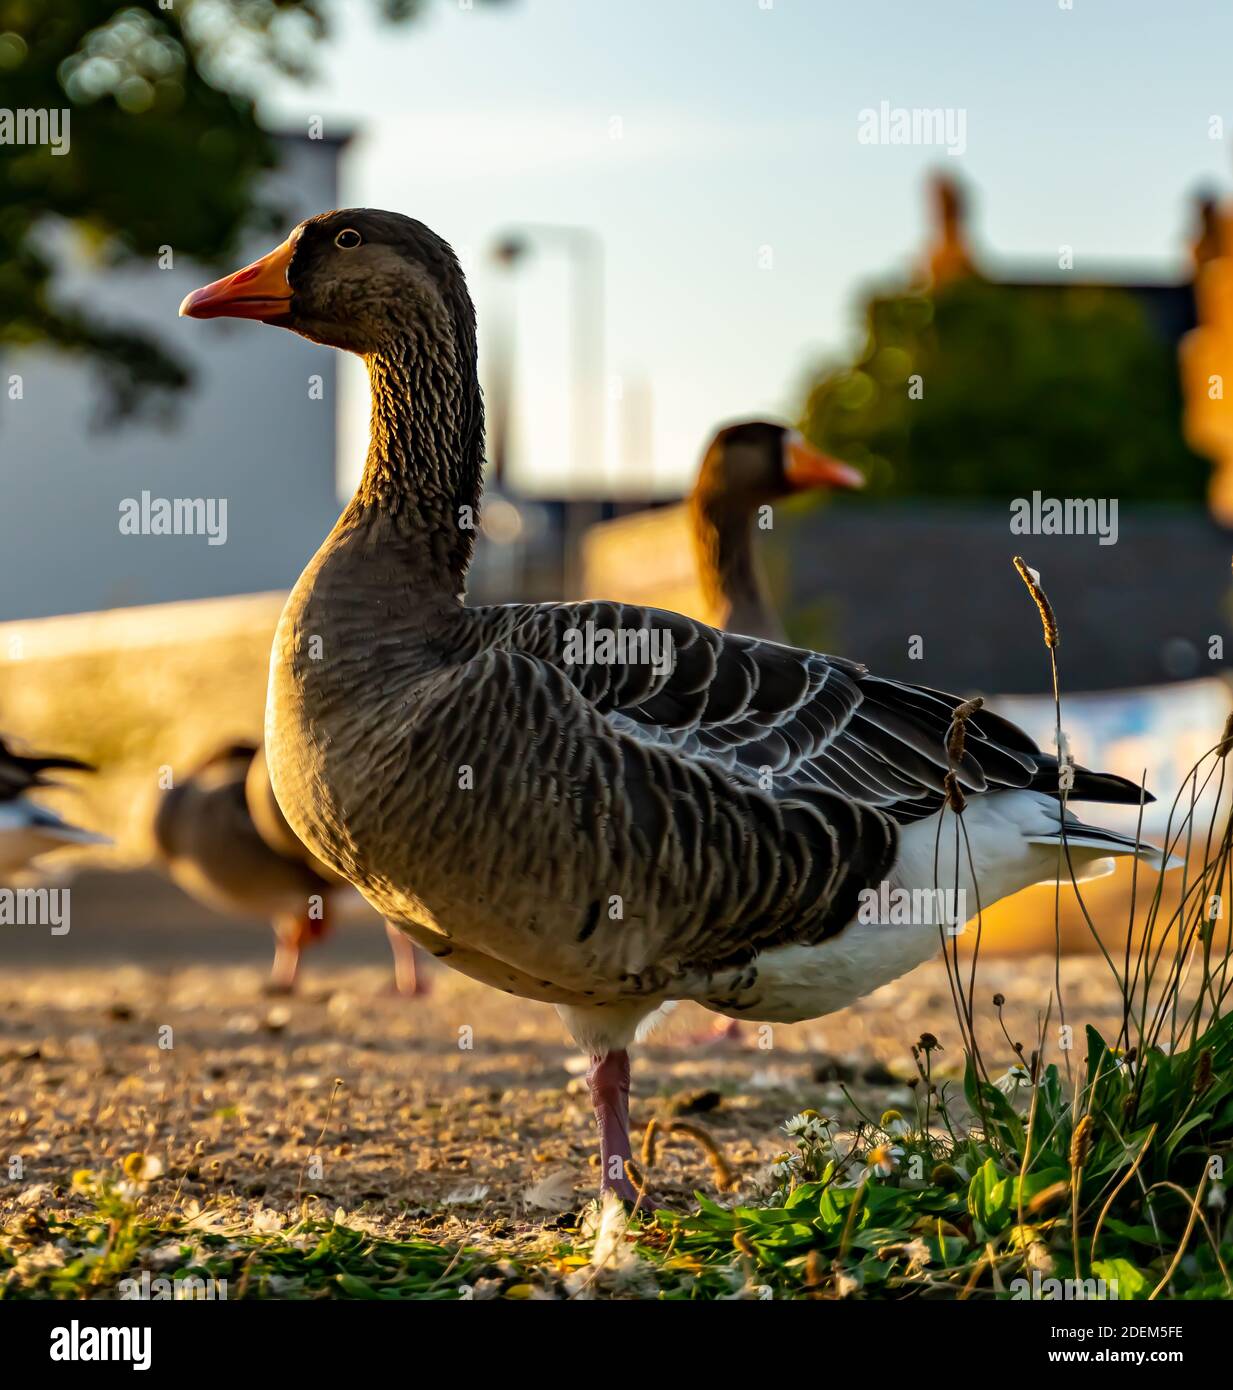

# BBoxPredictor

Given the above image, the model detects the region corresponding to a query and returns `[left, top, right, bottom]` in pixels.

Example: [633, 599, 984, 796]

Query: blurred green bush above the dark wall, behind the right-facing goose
[803, 278, 1208, 500]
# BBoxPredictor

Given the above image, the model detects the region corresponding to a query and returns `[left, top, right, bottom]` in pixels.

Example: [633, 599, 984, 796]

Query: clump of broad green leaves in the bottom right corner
[659, 1020, 1233, 1300]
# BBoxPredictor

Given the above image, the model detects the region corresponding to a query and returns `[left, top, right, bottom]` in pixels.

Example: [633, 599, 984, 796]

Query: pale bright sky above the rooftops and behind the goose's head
[264, 0, 1233, 491]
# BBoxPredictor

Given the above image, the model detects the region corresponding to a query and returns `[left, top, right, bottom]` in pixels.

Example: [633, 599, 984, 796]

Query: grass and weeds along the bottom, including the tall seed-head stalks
[0, 566, 1233, 1301]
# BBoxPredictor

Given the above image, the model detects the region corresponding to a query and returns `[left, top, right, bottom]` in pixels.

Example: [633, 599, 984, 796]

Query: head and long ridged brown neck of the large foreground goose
[179, 207, 484, 599]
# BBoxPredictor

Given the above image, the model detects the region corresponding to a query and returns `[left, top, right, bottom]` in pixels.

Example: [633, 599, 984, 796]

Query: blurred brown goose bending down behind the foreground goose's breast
[153, 744, 418, 994]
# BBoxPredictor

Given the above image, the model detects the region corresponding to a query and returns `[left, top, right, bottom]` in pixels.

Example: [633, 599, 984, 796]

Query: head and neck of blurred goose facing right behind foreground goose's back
[689, 420, 865, 642]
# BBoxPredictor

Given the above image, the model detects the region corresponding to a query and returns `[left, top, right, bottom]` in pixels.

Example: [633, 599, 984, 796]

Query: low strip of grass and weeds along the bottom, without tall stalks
[0, 1000, 1233, 1300]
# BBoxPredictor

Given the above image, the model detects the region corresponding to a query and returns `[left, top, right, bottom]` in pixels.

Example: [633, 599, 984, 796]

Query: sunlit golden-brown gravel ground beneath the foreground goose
[0, 887, 1145, 1234]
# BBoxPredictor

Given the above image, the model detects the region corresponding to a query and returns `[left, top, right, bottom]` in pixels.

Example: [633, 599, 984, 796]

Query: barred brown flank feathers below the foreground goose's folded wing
[444, 631, 897, 978]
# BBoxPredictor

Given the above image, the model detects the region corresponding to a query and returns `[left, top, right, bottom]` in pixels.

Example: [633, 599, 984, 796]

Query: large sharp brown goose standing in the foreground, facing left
[181, 209, 1178, 1198]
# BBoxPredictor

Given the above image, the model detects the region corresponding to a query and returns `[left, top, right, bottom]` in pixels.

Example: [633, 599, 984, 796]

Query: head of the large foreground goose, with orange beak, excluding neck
[179, 207, 474, 357]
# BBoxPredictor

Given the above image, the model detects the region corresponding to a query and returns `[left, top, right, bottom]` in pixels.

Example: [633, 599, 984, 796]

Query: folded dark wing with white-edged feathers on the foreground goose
[469, 602, 1138, 821]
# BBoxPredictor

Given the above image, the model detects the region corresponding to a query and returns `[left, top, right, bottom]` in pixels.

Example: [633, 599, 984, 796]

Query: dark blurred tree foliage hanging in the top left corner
[0, 0, 486, 416]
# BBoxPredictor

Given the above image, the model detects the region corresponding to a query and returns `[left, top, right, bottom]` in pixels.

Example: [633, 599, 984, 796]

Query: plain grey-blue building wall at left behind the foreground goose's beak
[0, 139, 351, 620]
